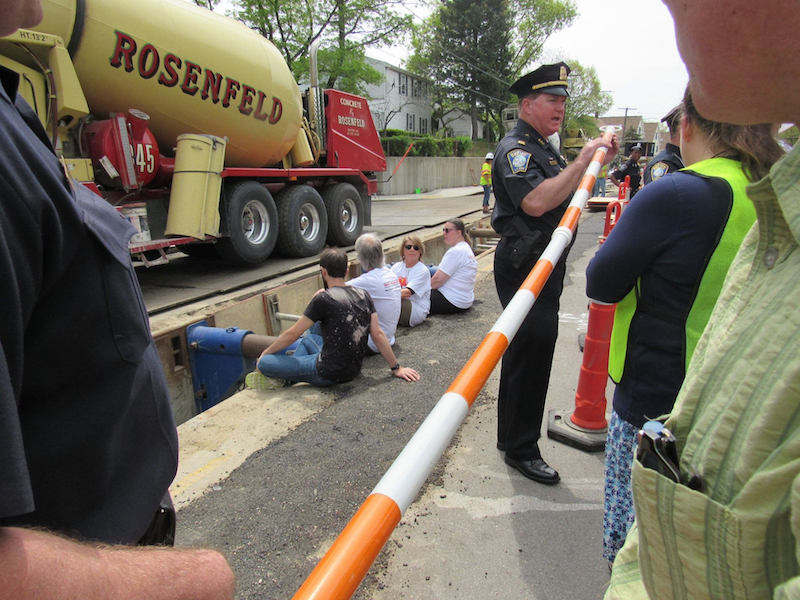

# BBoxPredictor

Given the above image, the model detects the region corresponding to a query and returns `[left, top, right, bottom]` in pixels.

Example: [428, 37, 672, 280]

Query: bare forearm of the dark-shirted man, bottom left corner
[0, 527, 234, 600]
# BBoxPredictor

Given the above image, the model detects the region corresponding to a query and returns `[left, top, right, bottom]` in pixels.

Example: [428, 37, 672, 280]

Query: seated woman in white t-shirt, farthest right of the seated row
[430, 219, 478, 315]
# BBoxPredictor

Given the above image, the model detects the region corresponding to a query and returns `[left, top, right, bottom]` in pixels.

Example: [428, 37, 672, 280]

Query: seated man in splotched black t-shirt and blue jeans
[252, 248, 419, 389]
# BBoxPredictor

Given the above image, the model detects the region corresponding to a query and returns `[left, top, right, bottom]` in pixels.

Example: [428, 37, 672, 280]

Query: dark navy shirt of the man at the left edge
[0, 67, 178, 543]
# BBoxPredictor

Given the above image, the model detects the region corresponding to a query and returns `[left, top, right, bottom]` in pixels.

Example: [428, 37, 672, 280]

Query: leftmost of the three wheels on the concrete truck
[216, 181, 278, 265]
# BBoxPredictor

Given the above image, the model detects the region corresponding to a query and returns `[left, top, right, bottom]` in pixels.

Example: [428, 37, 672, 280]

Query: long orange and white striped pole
[294, 129, 614, 600]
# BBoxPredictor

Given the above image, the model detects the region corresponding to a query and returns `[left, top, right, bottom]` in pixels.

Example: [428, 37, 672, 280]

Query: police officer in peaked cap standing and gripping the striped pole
[492, 62, 617, 484]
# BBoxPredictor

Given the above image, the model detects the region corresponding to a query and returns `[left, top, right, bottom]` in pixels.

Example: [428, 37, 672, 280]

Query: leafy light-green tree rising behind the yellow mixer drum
[228, 0, 411, 94]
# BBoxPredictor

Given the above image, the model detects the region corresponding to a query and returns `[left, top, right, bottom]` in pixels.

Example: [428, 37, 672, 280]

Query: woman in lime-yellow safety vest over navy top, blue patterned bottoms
[586, 85, 782, 564]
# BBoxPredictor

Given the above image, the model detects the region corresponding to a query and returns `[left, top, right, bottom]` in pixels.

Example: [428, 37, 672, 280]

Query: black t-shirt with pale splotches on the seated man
[303, 286, 375, 382]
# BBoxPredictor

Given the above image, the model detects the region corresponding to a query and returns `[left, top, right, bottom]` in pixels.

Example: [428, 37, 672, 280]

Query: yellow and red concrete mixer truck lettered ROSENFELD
[0, 0, 386, 265]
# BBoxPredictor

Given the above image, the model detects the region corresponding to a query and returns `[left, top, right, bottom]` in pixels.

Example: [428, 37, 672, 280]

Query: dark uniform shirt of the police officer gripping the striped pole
[492, 120, 571, 239]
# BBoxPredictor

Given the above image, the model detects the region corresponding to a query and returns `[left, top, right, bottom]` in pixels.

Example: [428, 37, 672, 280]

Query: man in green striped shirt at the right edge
[606, 0, 800, 599]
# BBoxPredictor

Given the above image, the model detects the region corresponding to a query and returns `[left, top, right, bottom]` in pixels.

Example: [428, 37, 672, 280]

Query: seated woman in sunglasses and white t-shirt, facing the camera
[392, 235, 431, 327]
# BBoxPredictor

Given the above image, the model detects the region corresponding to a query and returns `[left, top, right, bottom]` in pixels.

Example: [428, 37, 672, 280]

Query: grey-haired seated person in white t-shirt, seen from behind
[347, 233, 400, 354]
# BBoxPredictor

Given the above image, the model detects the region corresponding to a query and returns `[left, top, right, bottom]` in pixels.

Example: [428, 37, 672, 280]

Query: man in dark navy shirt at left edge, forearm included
[0, 0, 234, 600]
